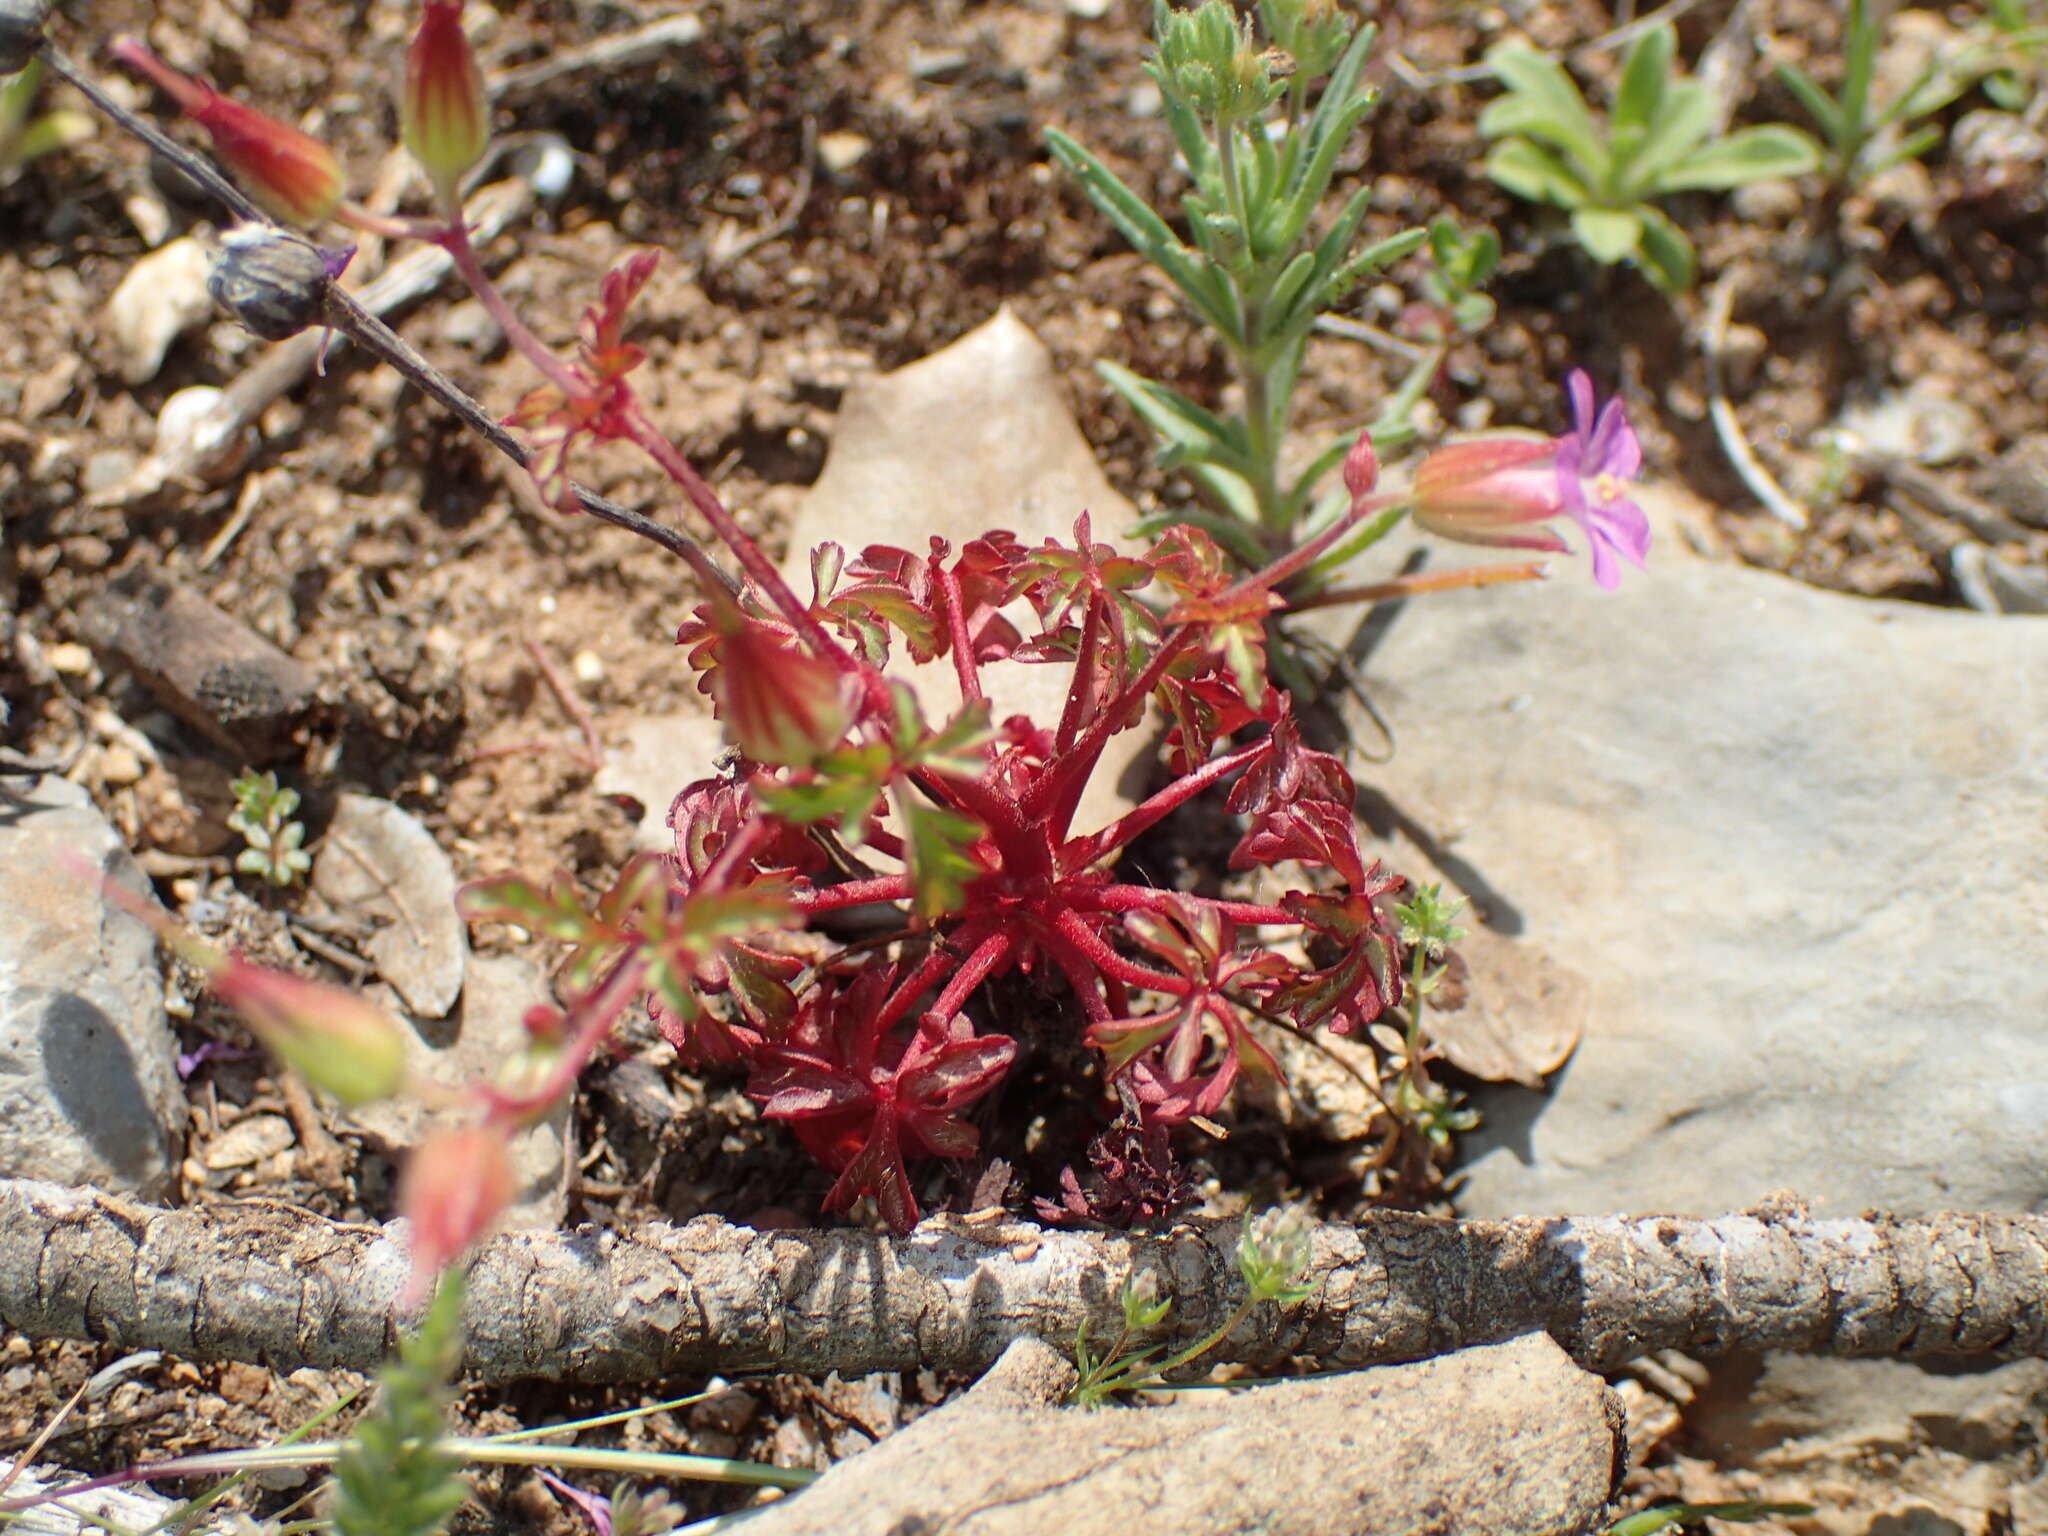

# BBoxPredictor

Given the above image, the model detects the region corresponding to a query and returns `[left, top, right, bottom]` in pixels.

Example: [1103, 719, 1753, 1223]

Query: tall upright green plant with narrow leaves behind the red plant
[1047, 0, 1423, 567]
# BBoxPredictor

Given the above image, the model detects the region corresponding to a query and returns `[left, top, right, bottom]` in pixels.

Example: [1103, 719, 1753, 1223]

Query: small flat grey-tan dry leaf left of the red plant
[313, 795, 469, 1018]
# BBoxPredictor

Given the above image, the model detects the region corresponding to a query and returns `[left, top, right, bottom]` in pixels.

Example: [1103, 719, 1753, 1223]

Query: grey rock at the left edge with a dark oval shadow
[0, 776, 184, 1196]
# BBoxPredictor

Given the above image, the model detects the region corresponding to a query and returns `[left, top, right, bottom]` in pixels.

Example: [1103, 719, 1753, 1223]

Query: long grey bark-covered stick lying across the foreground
[0, 1182, 2048, 1380]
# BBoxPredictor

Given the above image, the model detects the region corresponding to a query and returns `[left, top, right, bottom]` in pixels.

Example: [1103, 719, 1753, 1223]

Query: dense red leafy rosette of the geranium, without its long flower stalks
[452, 397, 1403, 1229]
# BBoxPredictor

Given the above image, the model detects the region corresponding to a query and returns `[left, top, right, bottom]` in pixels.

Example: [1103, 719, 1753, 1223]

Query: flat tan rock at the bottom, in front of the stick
[750, 1333, 1624, 1536]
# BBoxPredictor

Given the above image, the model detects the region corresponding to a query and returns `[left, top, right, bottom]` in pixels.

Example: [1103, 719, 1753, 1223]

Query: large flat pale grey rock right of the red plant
[1327, 543, 2048, 1217]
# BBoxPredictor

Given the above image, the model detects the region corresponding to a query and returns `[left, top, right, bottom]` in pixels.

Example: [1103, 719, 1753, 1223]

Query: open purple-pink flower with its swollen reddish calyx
[1413, 369, 1651, 588]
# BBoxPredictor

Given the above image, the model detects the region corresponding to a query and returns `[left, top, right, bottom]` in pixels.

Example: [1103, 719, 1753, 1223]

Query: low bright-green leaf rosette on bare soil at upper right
[1479, 23, 1821, 295]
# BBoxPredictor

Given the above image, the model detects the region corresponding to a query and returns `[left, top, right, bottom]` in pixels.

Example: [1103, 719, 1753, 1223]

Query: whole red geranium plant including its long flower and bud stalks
[96, 0, 1647, 1266]
